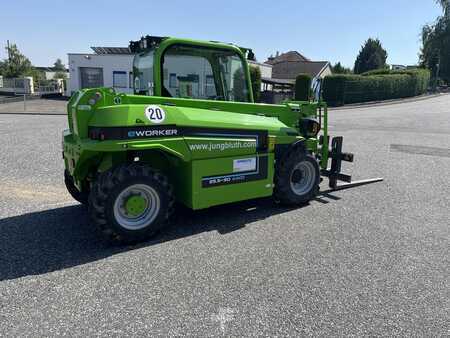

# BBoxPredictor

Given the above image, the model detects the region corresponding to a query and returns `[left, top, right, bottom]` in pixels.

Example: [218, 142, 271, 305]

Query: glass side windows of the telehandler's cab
[133, 45, 250, 102]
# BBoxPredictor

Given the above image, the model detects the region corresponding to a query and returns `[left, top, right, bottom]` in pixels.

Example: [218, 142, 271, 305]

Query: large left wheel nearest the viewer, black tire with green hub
[89, 163, 174, 243]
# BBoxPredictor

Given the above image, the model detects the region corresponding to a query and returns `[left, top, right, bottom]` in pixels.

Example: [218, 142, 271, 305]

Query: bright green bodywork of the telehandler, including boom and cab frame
[63, 39, 328, 209]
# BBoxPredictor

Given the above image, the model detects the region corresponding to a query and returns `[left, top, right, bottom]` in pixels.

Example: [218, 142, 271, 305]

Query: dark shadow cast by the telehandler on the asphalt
[0, 191, 338, 281]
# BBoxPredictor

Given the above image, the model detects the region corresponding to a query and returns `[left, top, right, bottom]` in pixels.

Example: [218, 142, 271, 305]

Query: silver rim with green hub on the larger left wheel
[114, 184, 161, 230]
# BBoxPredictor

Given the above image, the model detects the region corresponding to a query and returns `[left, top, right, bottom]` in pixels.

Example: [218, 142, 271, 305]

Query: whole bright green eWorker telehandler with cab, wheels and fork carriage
[63, 36, 382, 243]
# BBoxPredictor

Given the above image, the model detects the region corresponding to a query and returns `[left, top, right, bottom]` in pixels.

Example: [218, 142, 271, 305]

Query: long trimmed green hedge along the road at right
[323, 69, 430, 106]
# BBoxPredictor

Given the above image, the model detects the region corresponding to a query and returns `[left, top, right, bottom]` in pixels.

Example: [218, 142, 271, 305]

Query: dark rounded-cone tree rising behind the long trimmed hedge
[355, 38, 387, 74]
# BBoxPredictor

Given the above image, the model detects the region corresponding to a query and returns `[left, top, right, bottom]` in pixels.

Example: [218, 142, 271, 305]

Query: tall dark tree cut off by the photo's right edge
[420, 0, 450, 84]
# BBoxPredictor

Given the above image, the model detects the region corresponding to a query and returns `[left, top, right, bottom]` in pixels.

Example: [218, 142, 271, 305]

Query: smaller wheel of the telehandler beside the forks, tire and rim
[274, 146, 320, 205]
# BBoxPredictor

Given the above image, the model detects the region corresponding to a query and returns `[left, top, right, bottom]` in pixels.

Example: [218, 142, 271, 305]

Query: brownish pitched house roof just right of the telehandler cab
[272, 61, 330, 79]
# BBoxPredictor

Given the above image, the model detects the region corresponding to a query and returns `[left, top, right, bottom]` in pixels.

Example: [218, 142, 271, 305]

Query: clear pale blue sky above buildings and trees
[0, 0, 441, 67]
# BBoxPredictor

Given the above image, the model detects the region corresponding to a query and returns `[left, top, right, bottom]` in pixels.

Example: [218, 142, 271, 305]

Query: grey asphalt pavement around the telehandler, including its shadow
[0, 95, 450, 337]
